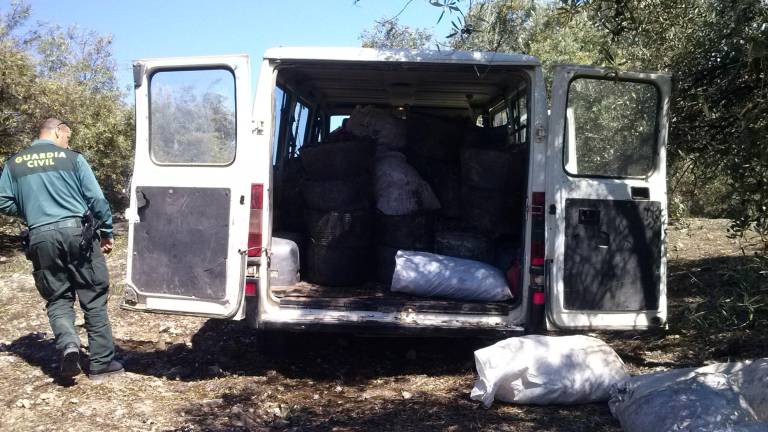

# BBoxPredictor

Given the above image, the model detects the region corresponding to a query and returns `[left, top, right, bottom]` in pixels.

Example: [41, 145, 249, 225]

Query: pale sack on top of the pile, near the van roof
[346, 105, 407, 150]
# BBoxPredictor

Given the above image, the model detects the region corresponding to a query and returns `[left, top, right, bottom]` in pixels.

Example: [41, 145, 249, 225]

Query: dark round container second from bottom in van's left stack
[305, 210, 373, 248]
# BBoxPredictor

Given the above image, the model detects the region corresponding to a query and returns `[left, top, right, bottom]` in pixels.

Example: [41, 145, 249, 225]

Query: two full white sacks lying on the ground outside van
[470, 335, 768, 432]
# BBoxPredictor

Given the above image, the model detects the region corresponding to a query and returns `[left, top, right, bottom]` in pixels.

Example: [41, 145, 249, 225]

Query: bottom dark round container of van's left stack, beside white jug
[305, 243, 373, 286]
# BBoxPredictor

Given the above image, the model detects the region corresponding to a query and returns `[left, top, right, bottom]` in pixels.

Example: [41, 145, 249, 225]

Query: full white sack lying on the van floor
[392, 250, 512, 302]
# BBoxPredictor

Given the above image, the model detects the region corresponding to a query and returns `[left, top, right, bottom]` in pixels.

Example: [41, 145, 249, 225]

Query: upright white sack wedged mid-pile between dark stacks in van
[374, 151, 440, 216]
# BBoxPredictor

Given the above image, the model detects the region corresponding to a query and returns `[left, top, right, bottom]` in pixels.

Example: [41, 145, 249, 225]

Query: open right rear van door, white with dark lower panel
[545, 65, 671, 329]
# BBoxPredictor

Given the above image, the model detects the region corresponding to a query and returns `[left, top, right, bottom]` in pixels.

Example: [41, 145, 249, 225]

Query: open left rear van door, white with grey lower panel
[123, 55, 255, 318]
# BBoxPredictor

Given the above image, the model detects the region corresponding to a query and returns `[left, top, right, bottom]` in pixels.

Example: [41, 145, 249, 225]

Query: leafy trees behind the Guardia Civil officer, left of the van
[0, 3, 134, 211]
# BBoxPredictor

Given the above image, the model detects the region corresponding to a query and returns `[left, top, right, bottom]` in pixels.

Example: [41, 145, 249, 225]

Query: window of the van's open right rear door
[563, 78, 659, 177]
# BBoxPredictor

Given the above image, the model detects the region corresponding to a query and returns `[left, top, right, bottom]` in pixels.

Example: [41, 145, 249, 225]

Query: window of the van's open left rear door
[149, 69, 237, 165]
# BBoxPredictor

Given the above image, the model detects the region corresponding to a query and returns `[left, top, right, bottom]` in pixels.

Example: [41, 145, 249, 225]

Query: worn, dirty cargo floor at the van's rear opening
[271, 281, 516, 315]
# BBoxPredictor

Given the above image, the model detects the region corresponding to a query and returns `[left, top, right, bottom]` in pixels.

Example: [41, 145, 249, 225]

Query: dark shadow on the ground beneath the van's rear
[118, 320, 488, 383]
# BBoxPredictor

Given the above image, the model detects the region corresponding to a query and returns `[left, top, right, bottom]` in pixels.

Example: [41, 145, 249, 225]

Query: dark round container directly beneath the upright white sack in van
[376, 213, 434, 251]
